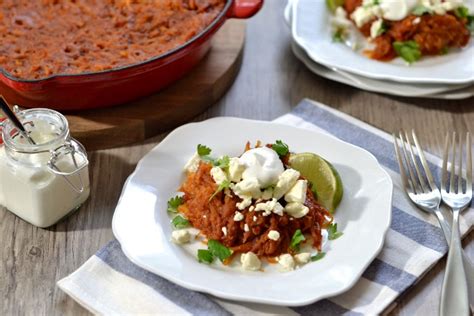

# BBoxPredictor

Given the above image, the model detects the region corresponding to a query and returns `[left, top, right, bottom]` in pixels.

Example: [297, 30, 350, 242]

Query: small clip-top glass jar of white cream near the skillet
[0, 109, 90, 227]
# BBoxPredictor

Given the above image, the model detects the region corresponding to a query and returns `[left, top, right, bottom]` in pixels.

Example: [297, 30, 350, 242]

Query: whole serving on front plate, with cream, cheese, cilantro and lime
[167, 140, 343, 271]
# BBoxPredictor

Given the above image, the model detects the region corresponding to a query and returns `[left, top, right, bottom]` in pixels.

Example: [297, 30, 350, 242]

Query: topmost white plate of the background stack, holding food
[292, 0, 474, 84]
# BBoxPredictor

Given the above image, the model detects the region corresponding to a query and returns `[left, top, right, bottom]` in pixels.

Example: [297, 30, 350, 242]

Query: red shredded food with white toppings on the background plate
[326, 0, 474, 64]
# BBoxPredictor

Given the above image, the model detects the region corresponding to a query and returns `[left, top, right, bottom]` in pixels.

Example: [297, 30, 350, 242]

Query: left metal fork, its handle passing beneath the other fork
[393, 130, 474, 305]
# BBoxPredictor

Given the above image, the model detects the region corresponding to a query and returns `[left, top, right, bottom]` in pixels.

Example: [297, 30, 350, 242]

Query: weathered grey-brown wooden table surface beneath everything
[0, 0, 474, 315]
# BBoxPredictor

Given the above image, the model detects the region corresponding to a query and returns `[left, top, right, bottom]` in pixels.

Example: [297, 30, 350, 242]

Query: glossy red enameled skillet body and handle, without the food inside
[0, 0, 263, 111]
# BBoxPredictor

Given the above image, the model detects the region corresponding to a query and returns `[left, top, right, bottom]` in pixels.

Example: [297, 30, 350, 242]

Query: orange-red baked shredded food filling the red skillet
[0, 0, 226, 79]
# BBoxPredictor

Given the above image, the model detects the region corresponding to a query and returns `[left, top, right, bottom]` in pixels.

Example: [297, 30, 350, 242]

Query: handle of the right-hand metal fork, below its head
[440, 209, 470, 316]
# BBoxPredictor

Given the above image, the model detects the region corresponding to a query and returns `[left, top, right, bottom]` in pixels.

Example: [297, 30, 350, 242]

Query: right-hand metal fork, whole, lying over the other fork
[440, 133, 472, 316]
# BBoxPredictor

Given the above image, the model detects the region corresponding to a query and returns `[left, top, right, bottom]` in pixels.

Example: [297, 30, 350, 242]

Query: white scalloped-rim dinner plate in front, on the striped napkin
[112, 117, 392, 306]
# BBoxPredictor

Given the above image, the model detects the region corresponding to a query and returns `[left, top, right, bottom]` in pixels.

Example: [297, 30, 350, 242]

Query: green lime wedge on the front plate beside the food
[288, 153, 343, 213]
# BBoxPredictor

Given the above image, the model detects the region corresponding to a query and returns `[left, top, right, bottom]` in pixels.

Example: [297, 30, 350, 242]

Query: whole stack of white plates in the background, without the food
[285, 0, 474, 99]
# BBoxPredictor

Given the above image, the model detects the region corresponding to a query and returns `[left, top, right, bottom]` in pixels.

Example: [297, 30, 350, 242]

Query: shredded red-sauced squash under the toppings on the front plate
[178, 148, 332, 258]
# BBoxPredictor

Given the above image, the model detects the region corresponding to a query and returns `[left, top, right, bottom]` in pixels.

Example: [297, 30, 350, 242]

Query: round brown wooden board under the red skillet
[65, 20, 245, 151]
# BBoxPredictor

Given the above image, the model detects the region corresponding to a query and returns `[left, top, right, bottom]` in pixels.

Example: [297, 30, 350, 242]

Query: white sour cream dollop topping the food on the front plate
[239, 147, 284, 188]
